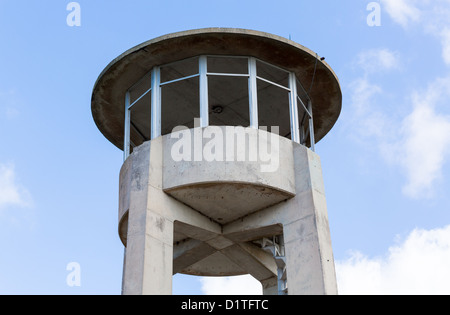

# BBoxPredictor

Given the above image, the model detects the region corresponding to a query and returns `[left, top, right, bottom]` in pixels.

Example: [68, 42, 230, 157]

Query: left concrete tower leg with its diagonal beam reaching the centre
[119, 137, 221, 295]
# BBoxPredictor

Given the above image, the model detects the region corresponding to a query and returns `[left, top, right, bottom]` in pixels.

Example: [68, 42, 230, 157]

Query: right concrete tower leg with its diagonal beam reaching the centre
[224, 144, 337, 295]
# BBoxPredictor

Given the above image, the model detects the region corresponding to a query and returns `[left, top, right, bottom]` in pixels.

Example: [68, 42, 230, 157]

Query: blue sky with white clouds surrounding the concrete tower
[0, 0, 450, 294]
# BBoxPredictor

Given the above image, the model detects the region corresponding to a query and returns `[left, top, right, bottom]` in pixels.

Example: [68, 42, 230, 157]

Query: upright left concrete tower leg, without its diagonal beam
[123, 141, 174, 295]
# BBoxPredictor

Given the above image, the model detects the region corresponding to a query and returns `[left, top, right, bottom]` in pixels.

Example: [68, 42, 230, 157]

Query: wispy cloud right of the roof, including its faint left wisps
[349, 49, 450, 199]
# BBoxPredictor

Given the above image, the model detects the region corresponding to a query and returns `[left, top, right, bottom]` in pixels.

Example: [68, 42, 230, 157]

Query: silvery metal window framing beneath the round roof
[124, 55, 315, 159]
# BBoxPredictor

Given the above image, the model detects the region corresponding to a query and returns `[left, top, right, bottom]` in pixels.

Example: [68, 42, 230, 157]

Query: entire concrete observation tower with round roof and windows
[92, 28, 342, 295]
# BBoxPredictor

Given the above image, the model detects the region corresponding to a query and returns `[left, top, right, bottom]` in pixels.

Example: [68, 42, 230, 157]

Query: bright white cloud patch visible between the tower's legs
[200, 275, 262, 295]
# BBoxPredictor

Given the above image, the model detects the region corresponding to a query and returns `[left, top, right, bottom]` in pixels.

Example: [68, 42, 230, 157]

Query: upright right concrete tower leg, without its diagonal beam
[283, 146, 337, 294]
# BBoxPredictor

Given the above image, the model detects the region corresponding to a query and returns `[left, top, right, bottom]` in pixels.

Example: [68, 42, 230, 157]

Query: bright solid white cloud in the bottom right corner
[336, 226, 450, 294]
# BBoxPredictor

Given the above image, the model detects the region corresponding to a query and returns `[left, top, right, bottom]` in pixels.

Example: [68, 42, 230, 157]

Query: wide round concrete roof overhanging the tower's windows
[91, 28, 342, 150]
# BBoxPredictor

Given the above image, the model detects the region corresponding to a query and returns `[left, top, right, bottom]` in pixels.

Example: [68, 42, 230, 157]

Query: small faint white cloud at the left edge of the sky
[0, 164, 31, 210]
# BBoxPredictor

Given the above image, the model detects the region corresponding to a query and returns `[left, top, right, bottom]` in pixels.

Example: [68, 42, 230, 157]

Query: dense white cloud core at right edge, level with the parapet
[385, 77, 450, 198]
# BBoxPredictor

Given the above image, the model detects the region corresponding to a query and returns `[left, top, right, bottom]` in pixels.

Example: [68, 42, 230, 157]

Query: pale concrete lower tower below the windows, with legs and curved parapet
[119, 126, 337, 295]
